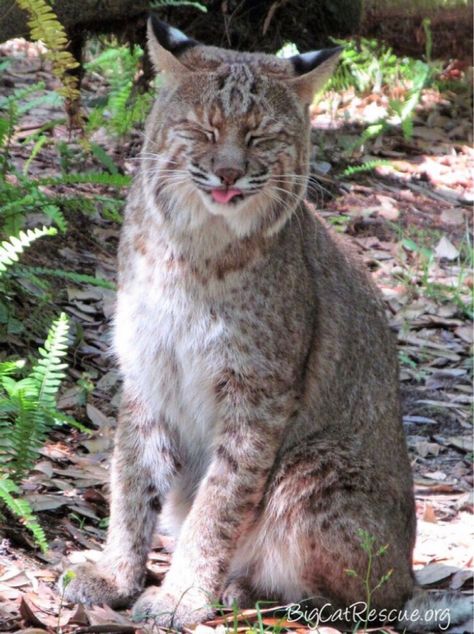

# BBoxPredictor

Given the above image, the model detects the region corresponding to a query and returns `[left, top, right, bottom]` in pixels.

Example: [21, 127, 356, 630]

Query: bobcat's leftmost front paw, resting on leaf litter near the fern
[58, 562, 140, 608]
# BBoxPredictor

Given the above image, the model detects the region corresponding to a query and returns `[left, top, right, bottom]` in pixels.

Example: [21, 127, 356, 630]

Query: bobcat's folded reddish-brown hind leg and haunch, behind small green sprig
[232, 440, 415, 620]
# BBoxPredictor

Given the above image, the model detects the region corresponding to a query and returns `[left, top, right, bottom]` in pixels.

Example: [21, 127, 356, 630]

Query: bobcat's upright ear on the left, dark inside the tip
[147, 14, 198, 74]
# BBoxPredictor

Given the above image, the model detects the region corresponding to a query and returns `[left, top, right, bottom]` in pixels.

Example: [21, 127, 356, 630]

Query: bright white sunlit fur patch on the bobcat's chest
[115, 264, 225, 447]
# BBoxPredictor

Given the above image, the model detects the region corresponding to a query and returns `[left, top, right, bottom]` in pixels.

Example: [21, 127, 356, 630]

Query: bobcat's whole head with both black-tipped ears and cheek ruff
[142, 18, 340, 236]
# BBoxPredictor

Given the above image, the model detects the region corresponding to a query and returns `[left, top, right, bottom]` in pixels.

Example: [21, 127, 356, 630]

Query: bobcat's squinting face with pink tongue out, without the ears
[163, 64, 307, 216]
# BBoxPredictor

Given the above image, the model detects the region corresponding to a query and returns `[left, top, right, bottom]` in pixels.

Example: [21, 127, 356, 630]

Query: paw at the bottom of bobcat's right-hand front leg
[132, 586, 214, 630]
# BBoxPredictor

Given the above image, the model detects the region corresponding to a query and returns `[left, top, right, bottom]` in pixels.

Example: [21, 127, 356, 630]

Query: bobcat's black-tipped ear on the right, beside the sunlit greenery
[288, 46, 342, 104]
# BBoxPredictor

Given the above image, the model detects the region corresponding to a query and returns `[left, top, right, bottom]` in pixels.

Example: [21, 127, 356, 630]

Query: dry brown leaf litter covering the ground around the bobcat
[0, 40, 474, 634]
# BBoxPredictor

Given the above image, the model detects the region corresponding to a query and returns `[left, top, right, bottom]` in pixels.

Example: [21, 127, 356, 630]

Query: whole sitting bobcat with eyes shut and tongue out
[65, 19, 470, 628]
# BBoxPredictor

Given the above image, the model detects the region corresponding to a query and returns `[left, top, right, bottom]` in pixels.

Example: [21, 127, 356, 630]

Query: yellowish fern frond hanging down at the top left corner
[16, 0, 80, 101]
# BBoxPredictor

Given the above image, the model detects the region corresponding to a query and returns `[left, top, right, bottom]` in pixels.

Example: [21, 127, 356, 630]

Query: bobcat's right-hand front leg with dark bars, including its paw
[134, 373, 294, 629]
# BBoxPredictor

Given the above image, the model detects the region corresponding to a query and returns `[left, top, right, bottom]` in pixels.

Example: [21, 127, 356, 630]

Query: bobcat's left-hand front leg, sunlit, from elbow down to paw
[60, 398, 179, 607]
